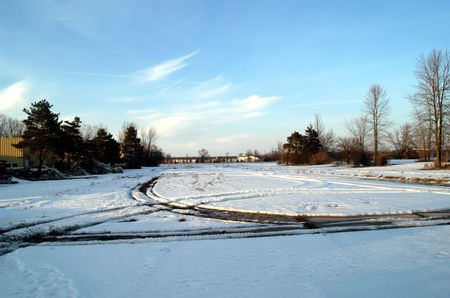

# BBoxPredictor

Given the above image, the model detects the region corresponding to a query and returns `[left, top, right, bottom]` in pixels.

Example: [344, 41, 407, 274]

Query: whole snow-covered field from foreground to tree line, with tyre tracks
[0, 163, 450, 297]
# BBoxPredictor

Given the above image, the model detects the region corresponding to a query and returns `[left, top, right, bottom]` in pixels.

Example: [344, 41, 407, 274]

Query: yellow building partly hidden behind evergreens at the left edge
[0, 138, 30, 167]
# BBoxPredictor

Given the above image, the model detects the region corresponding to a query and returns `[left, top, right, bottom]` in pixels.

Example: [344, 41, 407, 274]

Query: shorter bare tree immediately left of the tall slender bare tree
[345, 115, 369, 165]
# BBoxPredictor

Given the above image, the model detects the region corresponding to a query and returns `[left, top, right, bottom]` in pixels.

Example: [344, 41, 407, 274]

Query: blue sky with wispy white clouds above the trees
[0, 0, 450, 155]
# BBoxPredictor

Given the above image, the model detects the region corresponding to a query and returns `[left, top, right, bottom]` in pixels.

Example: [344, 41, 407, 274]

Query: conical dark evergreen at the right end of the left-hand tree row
[121, 124, 144, 168]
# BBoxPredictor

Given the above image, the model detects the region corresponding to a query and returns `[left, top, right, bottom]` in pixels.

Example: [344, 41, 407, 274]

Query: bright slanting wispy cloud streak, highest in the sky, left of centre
[137, 51, 198, 83]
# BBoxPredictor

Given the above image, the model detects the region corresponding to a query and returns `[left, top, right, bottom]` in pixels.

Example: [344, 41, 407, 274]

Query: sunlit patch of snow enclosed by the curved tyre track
[154, 165, 450, 215]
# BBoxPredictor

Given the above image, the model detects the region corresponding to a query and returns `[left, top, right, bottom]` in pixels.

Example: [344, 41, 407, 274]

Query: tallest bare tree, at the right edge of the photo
[410, 49, 450, 168]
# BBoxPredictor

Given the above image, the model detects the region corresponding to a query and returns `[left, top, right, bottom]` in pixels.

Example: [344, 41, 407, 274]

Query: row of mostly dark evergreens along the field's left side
[9, 99, 164, 177]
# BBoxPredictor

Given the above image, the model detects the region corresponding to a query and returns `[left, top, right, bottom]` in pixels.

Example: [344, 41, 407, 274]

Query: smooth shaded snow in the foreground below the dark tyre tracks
[0, 226, 450, 297]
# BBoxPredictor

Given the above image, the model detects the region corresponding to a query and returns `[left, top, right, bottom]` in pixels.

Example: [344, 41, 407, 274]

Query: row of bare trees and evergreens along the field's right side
[284, 50, 450, 168]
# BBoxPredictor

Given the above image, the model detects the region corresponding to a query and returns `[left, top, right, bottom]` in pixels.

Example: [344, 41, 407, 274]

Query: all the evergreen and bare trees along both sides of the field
[0, 49, 450, 169]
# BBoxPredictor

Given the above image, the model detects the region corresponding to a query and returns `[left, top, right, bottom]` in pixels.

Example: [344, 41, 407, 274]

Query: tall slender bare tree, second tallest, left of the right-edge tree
[364, 85, 391, 166]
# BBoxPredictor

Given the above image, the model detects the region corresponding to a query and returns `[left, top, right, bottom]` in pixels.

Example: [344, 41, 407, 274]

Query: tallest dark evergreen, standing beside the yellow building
[16, 99, 63, 177]
